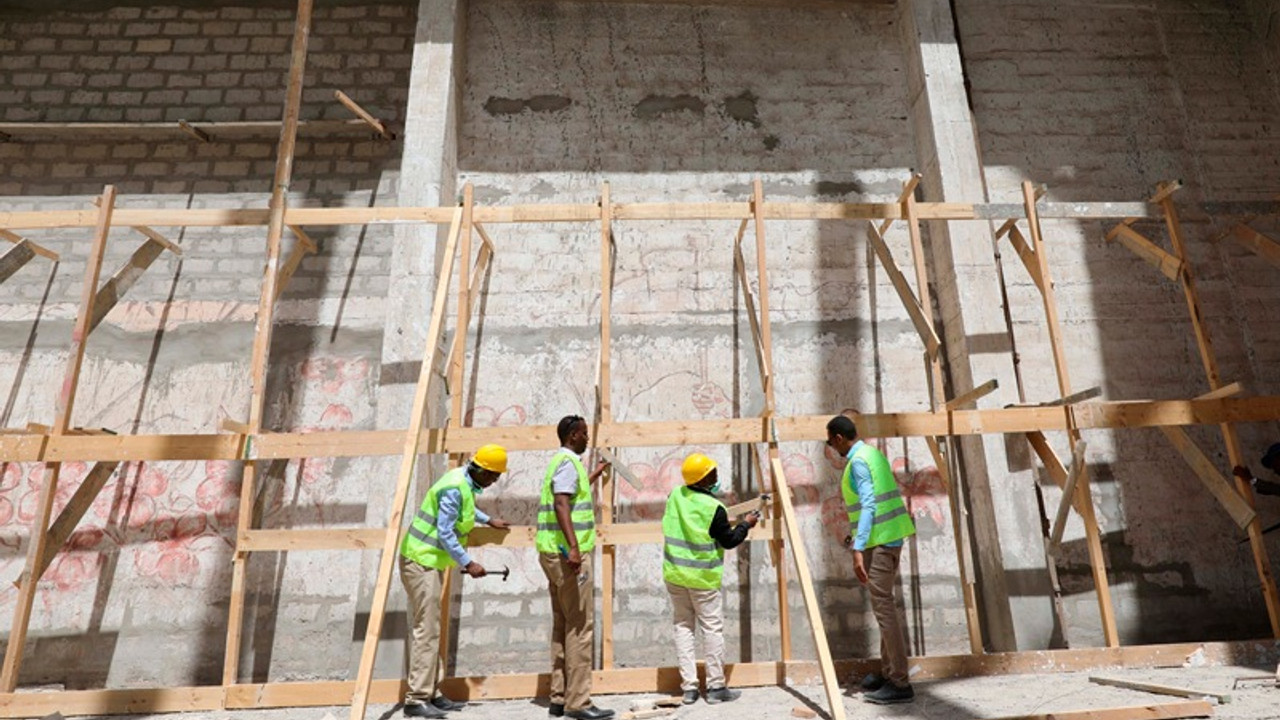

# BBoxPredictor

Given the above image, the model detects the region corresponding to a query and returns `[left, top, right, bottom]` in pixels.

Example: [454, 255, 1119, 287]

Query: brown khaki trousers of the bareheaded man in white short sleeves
[538, 552, 595, 711]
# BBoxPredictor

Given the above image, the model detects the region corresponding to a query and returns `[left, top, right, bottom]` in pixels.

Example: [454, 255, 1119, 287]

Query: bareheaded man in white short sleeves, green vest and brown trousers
[534, 415, 613, 720]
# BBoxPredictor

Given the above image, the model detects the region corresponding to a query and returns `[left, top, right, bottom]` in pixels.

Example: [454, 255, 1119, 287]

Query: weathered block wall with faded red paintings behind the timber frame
[0, 0, 1280, 685]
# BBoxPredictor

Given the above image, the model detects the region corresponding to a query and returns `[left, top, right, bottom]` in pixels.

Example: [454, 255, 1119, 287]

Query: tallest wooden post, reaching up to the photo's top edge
[223, 0, 312, 687]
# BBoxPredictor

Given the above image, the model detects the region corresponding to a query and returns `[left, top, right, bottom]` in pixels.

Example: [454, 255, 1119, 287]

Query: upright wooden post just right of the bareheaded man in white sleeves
[593, 183, 618, 670]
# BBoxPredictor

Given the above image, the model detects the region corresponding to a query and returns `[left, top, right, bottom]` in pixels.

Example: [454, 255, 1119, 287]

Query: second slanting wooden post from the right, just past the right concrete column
[1023, 181, 1120, 647]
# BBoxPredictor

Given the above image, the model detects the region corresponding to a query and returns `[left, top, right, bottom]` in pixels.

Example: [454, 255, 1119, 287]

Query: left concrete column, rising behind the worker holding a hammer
[352, 0, 467, 676]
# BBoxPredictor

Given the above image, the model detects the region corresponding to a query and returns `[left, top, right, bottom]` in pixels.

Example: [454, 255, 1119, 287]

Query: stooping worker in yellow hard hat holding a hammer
[399, 445, 509, 717]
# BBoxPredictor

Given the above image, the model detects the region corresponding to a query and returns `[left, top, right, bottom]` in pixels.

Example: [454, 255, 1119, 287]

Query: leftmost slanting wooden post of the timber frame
[0, 184, 115, 693]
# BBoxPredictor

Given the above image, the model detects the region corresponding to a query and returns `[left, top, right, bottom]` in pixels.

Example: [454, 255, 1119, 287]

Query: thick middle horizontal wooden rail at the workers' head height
[0, 396, 1280, 462]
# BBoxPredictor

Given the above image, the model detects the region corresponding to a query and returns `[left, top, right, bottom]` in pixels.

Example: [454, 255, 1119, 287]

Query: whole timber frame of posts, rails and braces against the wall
[0, 0, 1280, 720]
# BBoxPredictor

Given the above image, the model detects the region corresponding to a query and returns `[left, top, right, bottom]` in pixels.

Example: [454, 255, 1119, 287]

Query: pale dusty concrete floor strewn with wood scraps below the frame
[112, 666, 1280, 720]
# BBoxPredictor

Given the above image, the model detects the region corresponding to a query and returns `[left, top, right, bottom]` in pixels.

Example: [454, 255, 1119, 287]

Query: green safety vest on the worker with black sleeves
[662, 487, 724, 591]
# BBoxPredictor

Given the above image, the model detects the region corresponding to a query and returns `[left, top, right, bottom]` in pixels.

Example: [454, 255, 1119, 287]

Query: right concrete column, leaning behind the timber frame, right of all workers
[899, 0, 1033, 651]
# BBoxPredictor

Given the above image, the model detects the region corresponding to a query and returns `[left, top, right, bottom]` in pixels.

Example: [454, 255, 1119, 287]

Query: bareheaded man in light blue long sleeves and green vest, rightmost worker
[827, 415, 915, 705]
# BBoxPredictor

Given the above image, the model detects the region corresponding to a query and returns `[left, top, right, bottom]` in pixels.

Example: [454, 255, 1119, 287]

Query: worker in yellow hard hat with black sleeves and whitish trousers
[662, 452, 760, 705]
